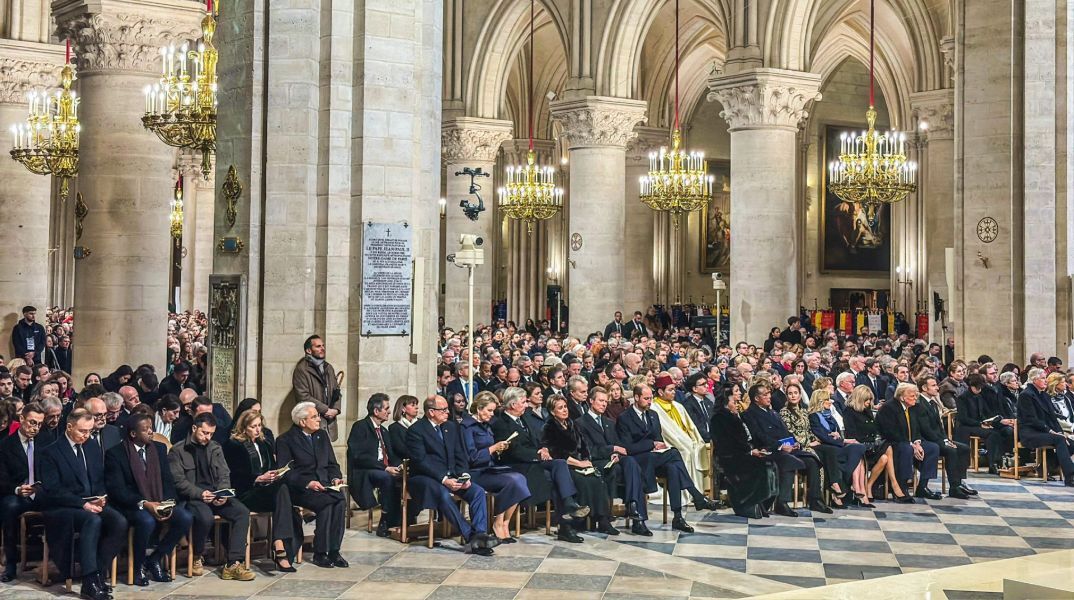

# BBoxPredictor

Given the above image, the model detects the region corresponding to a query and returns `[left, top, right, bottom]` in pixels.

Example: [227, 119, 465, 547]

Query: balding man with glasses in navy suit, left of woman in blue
[406, 396, 496, 556]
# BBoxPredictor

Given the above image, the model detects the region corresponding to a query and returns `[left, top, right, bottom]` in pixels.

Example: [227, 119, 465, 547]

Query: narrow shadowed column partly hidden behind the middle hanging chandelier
[623, 127, 670, 311]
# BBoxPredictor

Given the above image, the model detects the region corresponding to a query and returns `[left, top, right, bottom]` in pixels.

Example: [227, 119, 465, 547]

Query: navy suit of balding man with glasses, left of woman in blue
[406, 419, 489, 541]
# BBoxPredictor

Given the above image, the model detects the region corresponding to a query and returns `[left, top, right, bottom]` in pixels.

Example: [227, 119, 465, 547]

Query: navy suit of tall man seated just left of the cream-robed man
[615, 407, 702, 514]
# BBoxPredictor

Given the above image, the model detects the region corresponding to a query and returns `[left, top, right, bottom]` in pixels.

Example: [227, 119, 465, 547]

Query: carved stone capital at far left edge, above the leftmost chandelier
[0, 40, 63, 104]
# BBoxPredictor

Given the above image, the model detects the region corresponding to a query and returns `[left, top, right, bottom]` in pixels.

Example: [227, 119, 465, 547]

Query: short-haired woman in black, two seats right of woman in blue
[541, 394, 619, 541]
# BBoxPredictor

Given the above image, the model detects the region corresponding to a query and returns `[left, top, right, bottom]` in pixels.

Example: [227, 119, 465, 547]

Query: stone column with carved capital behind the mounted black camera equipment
[440, 117, 511, 331]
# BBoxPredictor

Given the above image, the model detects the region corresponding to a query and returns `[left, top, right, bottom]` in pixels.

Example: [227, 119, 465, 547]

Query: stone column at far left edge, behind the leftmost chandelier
[0, 40, 62, 349]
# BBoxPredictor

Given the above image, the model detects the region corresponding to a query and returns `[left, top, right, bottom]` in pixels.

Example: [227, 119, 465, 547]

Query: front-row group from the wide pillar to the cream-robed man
[347, 385, 716, 555]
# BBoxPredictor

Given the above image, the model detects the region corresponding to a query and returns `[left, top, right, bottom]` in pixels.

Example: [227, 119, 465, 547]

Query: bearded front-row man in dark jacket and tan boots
[168, 412, 255, 582]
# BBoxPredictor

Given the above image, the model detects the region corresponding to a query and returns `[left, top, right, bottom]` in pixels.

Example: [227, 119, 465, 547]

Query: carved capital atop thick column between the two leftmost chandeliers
[57, 13, 201, 73]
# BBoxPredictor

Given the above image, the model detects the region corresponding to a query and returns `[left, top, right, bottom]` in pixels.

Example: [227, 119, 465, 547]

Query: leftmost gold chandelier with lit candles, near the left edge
[11, 40, 82, 200]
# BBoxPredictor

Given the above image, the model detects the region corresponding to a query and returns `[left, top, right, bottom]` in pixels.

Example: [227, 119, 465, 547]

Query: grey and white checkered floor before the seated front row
[0, 477, 1074, 600]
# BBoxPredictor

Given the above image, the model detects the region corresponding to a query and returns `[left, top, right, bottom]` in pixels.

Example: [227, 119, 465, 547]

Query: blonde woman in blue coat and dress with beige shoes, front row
[462, 392, 529, 544]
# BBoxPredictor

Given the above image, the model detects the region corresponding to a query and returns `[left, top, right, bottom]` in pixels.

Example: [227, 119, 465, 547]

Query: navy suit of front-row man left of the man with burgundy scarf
[34, 434, 127, 576]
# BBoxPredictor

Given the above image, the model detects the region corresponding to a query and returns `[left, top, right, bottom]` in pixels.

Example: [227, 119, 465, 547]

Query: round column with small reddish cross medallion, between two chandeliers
[551, 96, 647, 339]
